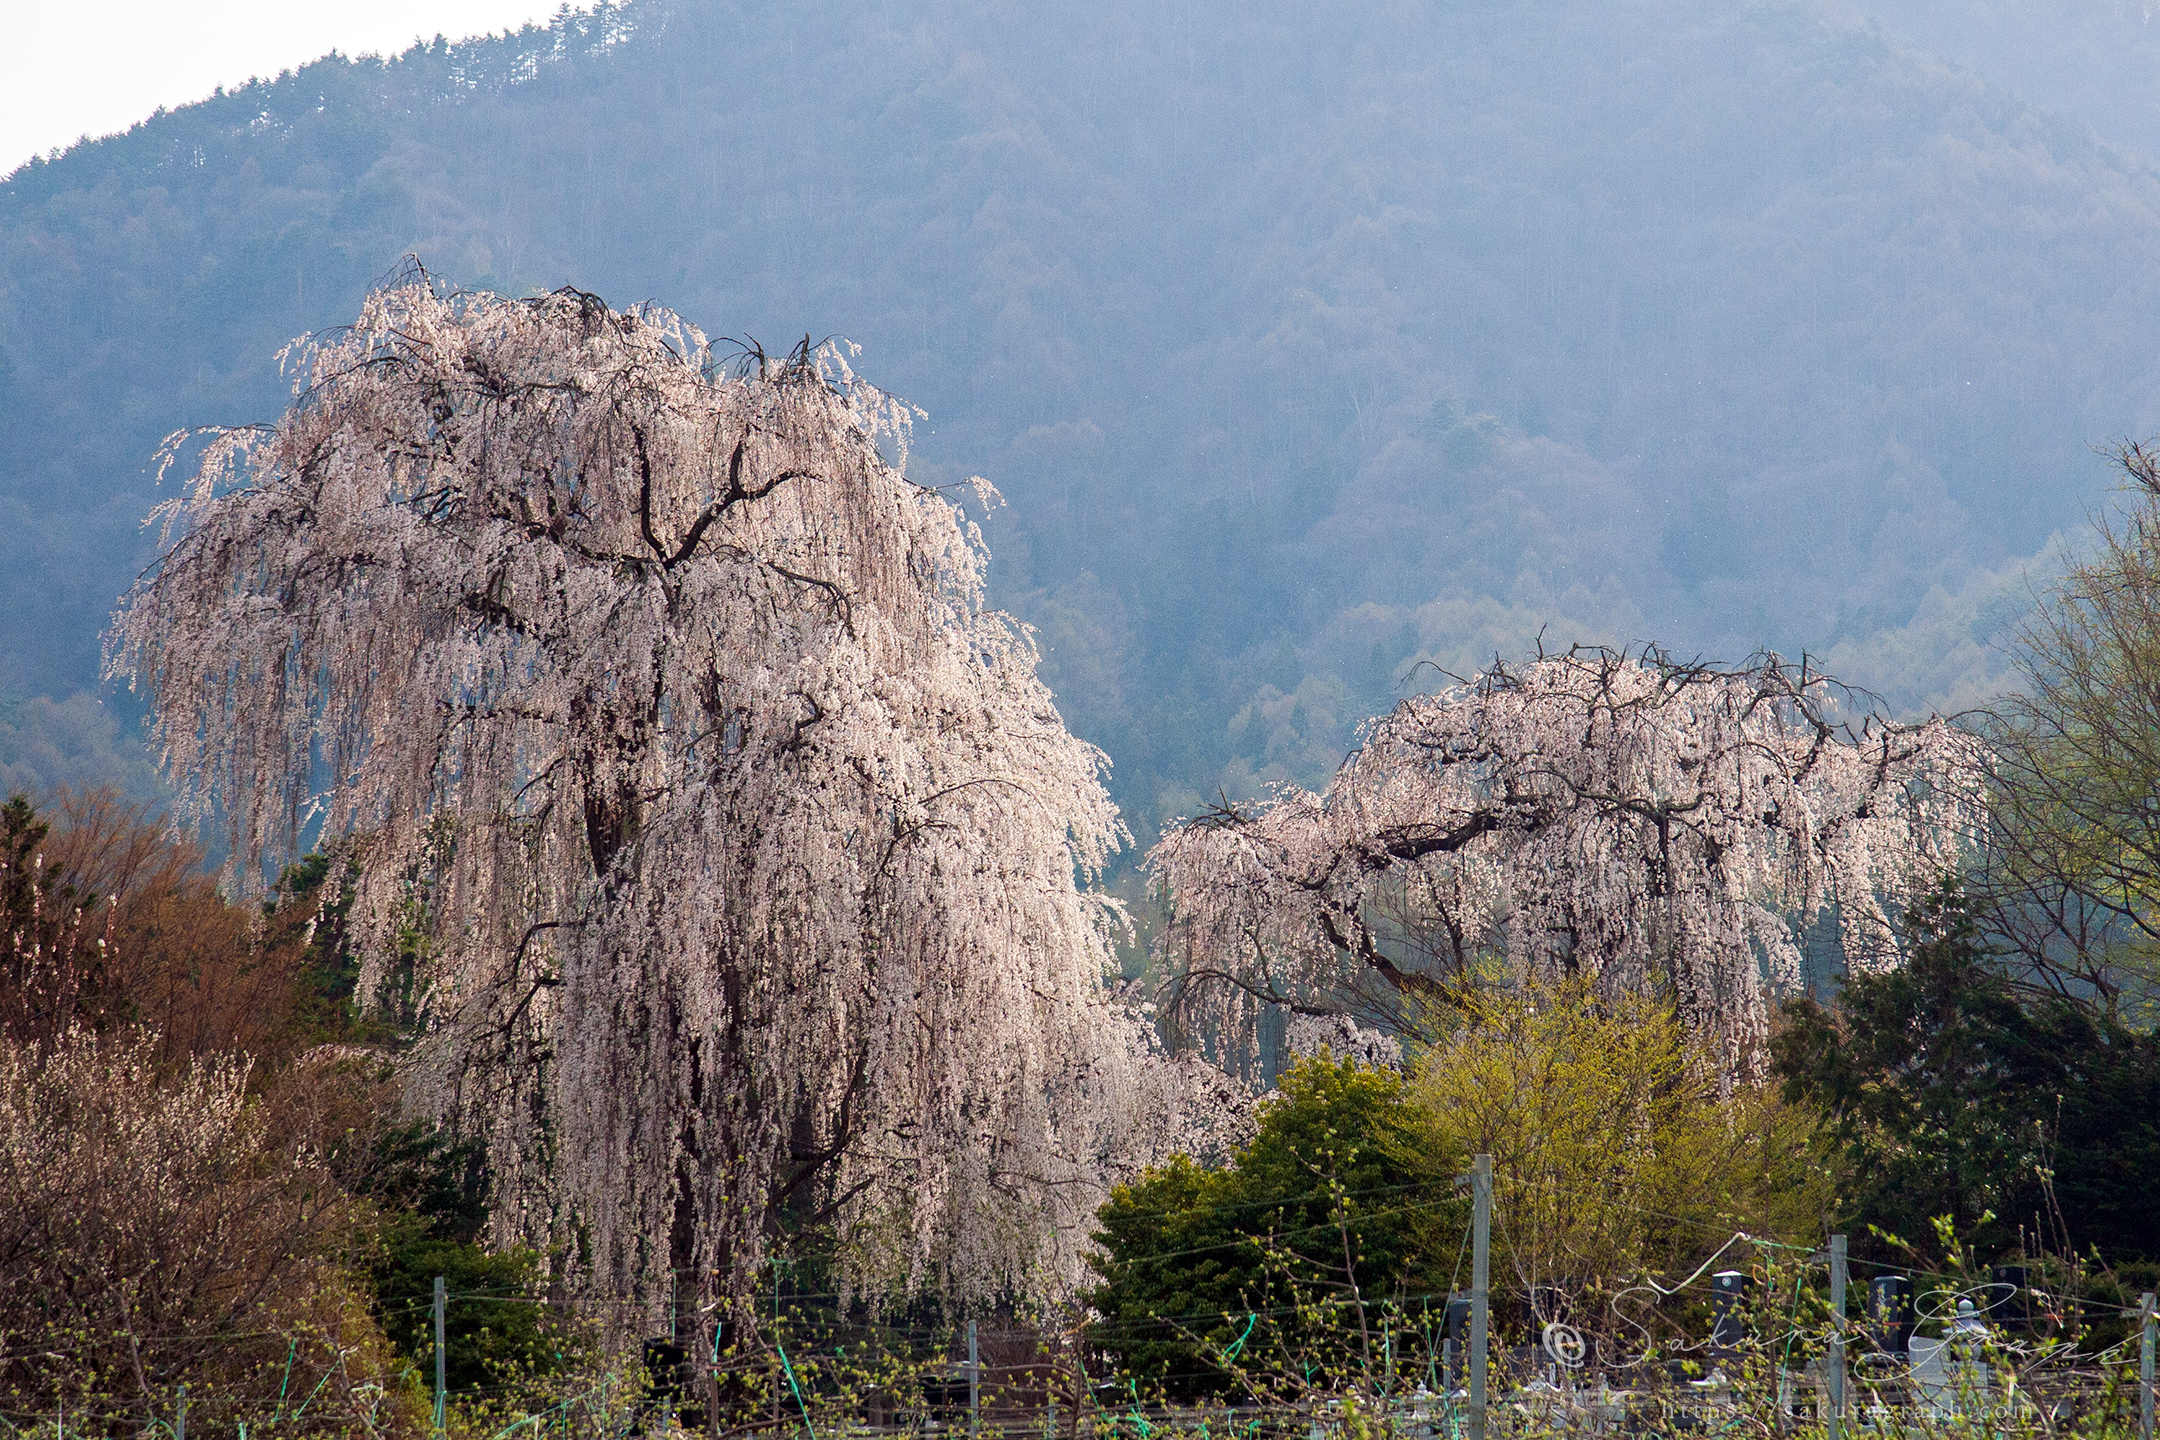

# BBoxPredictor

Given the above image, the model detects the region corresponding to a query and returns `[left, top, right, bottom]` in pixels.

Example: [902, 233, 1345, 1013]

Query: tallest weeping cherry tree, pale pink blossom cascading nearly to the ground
[110, 276, 1235, 1319]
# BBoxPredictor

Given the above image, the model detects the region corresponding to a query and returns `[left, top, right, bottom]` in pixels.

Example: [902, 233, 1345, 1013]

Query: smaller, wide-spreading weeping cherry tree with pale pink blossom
[1149, 650, 1981, 1071]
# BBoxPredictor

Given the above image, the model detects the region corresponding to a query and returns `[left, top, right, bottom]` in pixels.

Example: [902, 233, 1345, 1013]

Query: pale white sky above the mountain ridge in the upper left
[0, 0, 588, 175]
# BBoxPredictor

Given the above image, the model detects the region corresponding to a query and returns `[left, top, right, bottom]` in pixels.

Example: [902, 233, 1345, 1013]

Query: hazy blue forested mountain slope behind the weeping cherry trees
[0, 0, 2160, 831]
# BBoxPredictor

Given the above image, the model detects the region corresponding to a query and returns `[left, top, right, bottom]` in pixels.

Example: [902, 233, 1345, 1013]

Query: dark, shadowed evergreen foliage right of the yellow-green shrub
[1773, 892, 2160, 1263]
